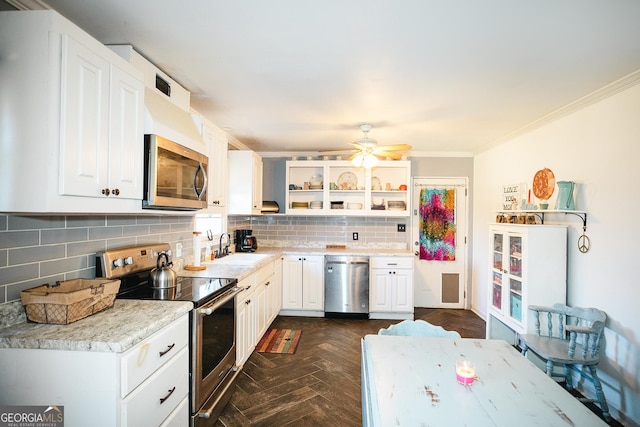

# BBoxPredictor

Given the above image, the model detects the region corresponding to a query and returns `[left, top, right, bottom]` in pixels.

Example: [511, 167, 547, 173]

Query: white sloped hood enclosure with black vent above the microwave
[109, 45, 204, 151]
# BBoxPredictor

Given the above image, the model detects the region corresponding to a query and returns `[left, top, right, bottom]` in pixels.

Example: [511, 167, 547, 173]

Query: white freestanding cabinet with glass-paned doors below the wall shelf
[487, 224, 567, 344]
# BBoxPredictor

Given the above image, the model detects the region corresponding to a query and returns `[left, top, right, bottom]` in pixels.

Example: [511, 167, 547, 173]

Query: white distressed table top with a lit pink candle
[362, 335, 607, 427]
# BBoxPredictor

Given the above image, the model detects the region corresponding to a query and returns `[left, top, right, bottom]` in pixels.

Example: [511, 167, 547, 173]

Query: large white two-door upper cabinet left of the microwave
[0, 11, 144, 213]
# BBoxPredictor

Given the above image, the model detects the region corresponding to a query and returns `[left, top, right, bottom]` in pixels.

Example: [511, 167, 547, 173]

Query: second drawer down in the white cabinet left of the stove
[122, 347, 189, 427]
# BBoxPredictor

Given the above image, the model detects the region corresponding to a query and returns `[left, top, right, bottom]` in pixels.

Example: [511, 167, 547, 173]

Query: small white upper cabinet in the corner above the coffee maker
[227, 150, 262, 215]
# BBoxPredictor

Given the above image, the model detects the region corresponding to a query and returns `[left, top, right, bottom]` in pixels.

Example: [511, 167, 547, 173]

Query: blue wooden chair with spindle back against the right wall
[520, 304, 610, 421]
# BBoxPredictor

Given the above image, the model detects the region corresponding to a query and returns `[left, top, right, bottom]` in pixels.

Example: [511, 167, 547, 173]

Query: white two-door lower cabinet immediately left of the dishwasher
[280, 255, 324, 316]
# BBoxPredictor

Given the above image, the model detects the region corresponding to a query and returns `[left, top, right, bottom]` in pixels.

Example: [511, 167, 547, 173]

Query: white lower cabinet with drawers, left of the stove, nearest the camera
[0, 314, 189, 427]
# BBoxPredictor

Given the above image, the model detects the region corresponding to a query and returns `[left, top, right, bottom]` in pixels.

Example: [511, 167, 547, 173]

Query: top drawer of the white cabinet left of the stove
[120, 314, 189, 398]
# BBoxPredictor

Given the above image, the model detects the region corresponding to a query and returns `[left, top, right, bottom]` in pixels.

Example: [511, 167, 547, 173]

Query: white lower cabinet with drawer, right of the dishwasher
[369, 256, 413, 319]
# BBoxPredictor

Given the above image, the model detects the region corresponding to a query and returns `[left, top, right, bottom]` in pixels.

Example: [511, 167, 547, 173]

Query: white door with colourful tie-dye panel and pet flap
[411, 177, 468, 308]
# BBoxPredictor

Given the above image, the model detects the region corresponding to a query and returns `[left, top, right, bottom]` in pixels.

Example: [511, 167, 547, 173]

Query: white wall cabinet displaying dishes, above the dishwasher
[286, 160, 411, 217]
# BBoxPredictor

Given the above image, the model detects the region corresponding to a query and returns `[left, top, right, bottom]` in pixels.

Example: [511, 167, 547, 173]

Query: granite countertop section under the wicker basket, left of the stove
[0, 299, 193, 353]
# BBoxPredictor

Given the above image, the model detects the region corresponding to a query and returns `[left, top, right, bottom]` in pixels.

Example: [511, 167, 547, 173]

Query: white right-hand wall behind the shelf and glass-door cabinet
[471, 79, 640, 425]
